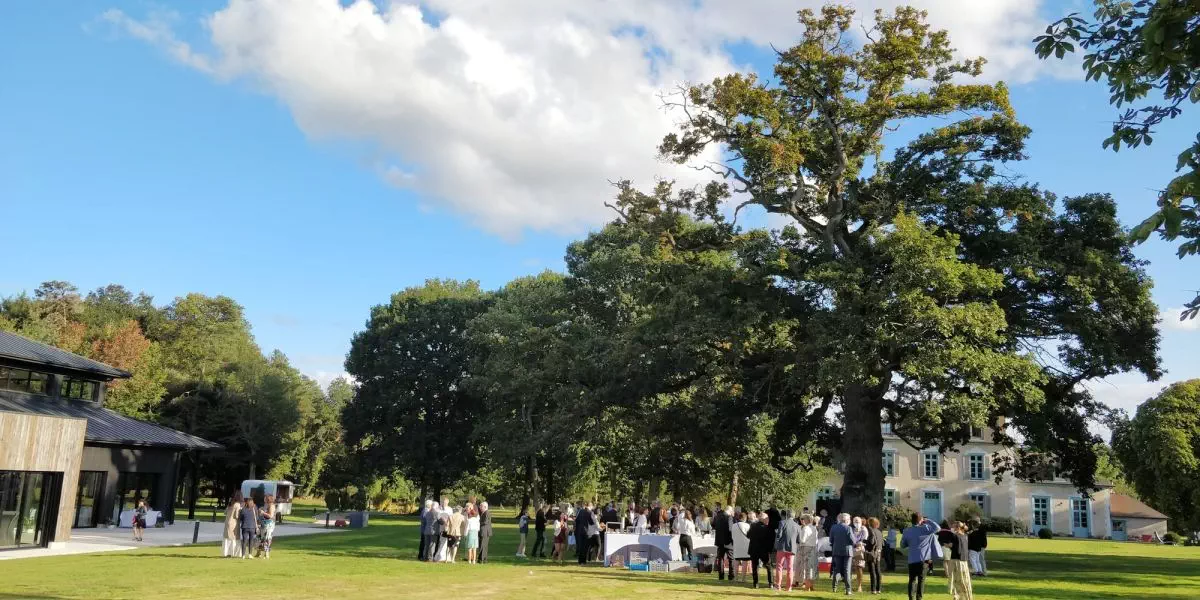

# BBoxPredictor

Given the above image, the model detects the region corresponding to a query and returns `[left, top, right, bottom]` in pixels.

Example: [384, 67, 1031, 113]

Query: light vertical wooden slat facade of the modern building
[0, 412, 88, 542]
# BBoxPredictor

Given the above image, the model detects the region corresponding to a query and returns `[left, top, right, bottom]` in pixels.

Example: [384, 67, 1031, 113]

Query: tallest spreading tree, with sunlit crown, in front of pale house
[633, 6, 1158, 514]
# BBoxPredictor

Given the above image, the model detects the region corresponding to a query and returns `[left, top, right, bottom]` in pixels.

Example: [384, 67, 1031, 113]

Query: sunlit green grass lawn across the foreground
[0, 516, 1200, 600]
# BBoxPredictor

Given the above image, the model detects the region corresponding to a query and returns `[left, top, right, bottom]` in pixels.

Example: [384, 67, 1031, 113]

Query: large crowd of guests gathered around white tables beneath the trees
[419, 497, 988, 600]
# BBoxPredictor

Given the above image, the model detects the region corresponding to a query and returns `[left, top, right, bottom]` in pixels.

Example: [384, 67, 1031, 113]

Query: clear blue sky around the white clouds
[0, 0, 1200, 422]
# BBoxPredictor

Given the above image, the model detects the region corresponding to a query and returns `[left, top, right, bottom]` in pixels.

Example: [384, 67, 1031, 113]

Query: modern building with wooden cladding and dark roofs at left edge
[0, 331, 221, 550]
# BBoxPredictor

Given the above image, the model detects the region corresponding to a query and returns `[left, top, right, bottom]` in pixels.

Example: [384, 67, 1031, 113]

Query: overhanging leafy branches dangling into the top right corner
[1033, 0, 1200, 319]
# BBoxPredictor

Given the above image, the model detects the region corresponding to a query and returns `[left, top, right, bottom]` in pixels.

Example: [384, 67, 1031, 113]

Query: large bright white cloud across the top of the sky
[102, 0, 1065, 236]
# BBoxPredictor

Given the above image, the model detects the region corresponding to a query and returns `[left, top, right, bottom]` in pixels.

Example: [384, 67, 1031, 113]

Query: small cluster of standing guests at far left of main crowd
[418, 496, 492, 564]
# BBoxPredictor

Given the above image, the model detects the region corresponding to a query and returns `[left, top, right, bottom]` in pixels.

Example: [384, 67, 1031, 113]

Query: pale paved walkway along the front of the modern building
[0, 521, 340, 560]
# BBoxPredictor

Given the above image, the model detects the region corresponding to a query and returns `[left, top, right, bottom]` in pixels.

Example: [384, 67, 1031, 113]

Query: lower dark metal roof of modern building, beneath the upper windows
[0, 394, 223, 450]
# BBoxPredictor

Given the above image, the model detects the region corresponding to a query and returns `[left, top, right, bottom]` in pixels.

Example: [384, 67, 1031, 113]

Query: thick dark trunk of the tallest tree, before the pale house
[841, 384, 887, 516]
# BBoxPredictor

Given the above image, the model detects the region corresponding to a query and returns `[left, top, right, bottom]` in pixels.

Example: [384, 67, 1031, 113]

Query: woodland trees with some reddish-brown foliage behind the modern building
[0, 281, 344, 496]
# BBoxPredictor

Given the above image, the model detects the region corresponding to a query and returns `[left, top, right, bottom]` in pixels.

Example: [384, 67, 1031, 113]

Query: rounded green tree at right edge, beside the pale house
[1112, 379, 1200, 530]
